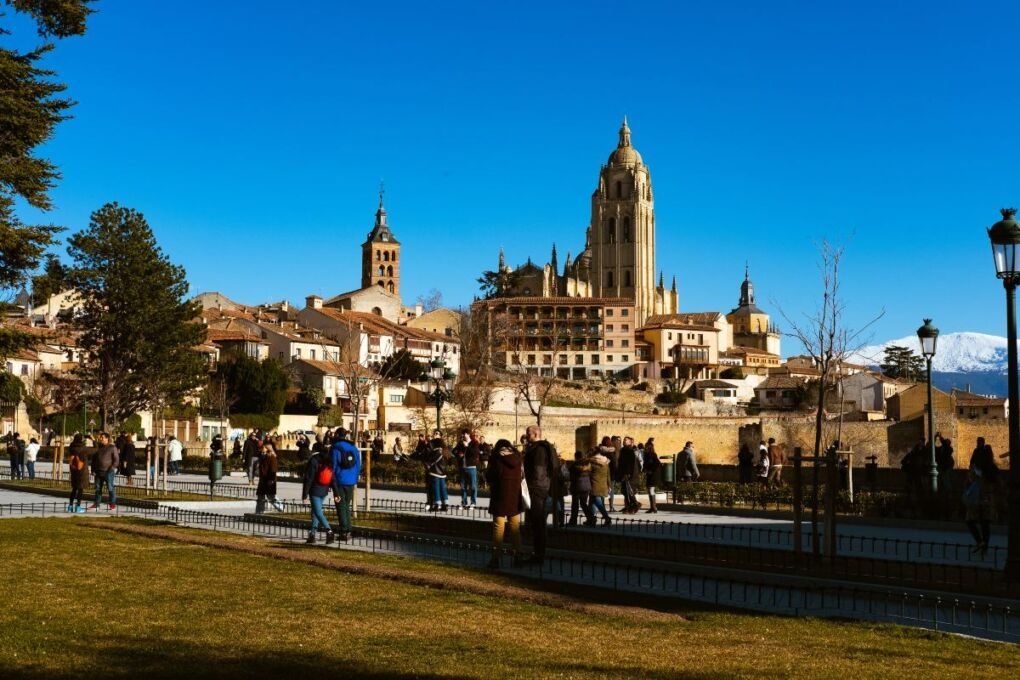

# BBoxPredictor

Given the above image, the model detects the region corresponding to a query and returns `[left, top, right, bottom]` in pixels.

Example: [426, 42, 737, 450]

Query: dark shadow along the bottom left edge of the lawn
[0, 640, 446, 680]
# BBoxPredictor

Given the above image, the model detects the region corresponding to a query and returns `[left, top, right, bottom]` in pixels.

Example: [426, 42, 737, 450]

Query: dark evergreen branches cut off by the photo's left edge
[0, 0, 92, 359]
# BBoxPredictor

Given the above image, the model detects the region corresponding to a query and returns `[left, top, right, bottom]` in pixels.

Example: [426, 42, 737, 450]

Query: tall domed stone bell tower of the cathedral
[591, 117, 656, 327]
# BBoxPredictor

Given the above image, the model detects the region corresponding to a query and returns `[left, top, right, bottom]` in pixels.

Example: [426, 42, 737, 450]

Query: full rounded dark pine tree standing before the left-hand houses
[66, 203, 206, 428]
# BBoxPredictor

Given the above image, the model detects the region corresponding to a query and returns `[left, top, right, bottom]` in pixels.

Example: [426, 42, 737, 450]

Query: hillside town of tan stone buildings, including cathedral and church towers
[2, 119, 1007, 467]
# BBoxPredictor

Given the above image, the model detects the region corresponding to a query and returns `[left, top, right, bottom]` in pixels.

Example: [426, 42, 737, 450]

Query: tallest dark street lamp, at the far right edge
[988, 208, 1020, 583]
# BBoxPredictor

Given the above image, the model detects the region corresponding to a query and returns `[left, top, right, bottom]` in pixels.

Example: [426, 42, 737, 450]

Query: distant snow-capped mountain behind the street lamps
[853, 332, 1009, 397]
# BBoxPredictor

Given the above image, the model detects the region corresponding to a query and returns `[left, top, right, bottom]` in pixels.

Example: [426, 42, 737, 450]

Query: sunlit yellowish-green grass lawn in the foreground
[0, 518, 1020, 680]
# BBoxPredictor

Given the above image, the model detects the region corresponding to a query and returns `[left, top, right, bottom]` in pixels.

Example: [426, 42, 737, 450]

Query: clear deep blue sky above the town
[11, 0, 1020, 354]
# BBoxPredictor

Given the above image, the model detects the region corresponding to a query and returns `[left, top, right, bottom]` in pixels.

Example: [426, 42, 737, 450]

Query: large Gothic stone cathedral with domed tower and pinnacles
[499, 117, 679, 326]
